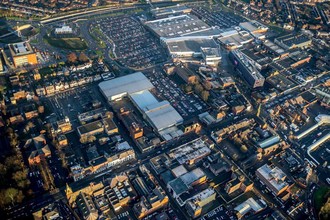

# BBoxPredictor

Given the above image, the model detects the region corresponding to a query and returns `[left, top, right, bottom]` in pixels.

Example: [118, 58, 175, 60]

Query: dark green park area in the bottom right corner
[314, 186, 330, 220]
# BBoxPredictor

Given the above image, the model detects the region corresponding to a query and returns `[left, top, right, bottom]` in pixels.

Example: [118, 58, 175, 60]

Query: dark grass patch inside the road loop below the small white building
[44, 36, 88, 50]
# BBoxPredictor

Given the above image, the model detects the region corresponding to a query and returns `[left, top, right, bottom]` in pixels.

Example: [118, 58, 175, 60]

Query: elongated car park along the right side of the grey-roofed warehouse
[145, 69, 208, 118]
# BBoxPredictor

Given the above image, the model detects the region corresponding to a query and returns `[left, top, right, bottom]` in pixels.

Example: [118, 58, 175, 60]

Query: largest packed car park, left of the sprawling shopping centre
[92, 16, 166, 69]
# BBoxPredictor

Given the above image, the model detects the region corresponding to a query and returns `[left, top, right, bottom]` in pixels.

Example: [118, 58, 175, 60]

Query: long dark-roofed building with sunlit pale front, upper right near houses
[274, 33, 312, 50]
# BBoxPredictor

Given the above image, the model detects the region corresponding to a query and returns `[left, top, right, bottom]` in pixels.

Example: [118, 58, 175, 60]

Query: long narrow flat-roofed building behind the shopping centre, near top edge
[151, 5, 191, 18]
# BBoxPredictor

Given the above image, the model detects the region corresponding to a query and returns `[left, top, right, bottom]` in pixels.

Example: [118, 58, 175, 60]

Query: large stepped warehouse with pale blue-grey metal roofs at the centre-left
[99, 72, 183, 140]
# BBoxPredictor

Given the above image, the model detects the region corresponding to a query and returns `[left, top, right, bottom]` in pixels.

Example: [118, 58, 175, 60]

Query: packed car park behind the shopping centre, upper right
[193, 7, 246, 28]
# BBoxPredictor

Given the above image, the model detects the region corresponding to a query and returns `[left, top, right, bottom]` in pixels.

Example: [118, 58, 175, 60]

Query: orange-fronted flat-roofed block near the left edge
[8, 42, 38, 67]
